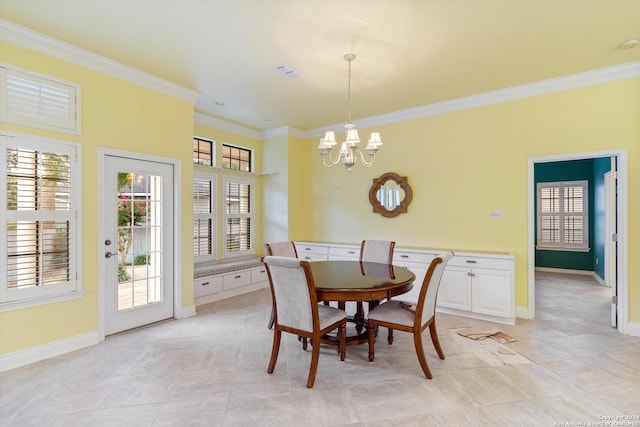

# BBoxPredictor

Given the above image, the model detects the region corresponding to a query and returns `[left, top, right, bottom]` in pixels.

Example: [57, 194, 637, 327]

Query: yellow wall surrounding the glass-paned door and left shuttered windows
[0, 42, 193, 354]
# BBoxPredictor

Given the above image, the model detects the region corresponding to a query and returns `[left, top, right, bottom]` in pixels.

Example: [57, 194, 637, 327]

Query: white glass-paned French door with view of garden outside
[100, 155, 174, 335]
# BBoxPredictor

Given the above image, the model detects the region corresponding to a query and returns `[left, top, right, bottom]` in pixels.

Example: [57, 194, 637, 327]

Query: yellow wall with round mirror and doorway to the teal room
[298, 78, 640, 322]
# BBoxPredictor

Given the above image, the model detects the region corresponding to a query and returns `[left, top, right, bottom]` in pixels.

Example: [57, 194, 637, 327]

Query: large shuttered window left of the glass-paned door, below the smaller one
[0, 136, 82, 310]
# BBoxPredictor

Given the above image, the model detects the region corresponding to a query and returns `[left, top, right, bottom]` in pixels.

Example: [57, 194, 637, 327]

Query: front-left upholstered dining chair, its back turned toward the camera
[263, 256, 347, 388]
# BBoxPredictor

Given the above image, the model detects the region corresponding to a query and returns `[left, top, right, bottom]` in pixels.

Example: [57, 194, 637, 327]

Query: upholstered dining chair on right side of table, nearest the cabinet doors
[368, 252, 453, 379]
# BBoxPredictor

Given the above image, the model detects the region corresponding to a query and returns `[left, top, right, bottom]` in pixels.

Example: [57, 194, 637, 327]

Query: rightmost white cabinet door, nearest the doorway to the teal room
[471, 269, 513, 317]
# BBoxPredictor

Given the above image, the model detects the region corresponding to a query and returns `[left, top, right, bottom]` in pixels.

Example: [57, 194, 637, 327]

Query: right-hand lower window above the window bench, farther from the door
[224, 176, 255, 257]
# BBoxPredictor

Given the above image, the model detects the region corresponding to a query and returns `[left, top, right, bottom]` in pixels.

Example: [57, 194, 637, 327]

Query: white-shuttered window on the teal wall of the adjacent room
[537, 181, 589, 250]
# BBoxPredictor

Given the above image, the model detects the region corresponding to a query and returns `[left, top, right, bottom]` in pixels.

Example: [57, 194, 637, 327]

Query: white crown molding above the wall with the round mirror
[304, 61, 640, 138]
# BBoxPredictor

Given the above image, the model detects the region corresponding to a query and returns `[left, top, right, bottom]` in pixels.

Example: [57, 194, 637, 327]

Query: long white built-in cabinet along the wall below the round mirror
[296, 242, 515, 324]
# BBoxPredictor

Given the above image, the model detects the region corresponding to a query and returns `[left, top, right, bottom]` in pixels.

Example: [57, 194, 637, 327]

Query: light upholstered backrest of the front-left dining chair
[263, 256, 318, 332]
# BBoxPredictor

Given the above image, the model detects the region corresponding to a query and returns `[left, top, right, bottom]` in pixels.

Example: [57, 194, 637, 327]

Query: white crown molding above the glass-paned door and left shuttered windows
[0, 18, 200, 105]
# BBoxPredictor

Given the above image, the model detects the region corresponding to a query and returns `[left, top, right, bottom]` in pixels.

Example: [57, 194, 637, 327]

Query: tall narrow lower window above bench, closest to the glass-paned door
[193, 172, 216, 262]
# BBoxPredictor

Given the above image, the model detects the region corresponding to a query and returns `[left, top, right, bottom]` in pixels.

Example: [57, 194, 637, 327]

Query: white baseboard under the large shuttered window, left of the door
[0, 331, 100, 372]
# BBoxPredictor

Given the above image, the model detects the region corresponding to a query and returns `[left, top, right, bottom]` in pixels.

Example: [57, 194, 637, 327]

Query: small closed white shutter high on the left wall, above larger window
[0, 67, 80, 134]
